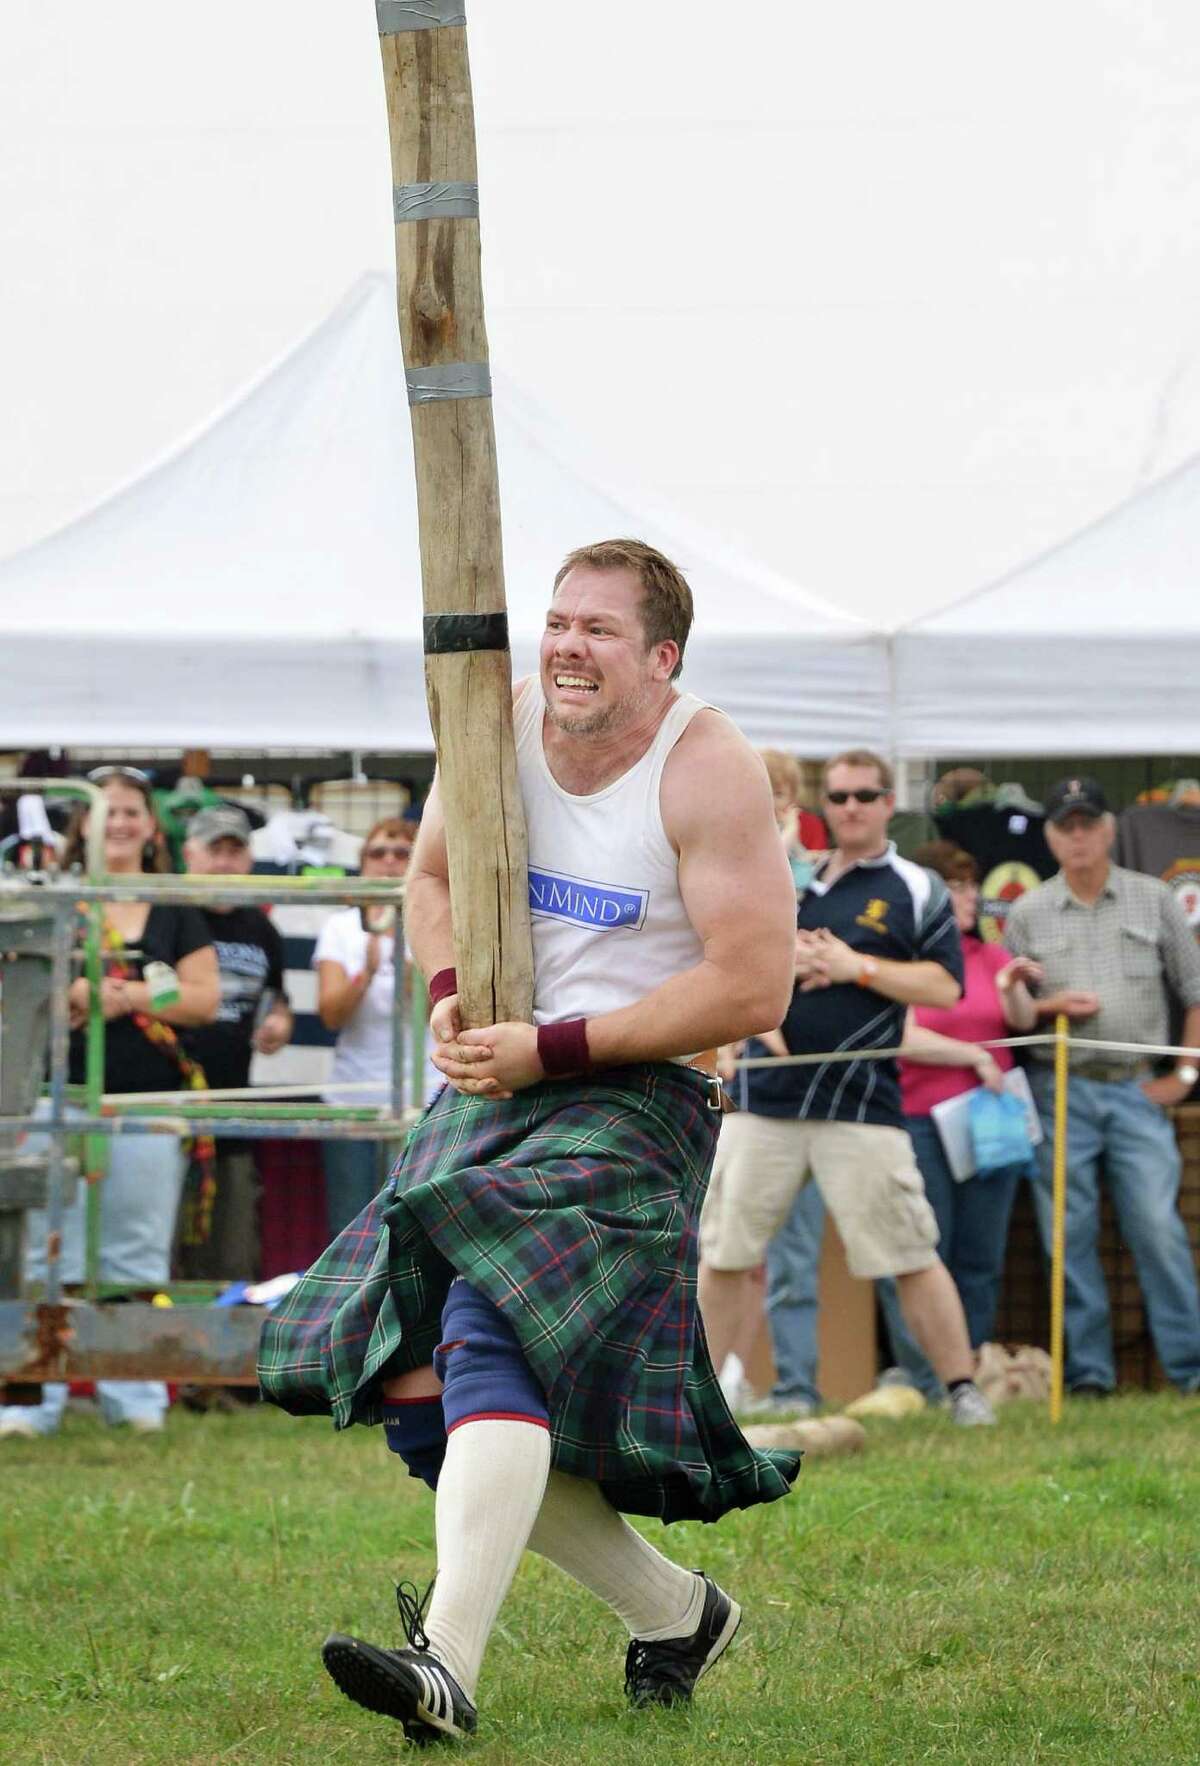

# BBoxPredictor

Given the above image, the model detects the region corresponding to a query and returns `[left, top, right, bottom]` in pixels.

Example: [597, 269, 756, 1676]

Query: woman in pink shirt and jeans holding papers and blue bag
[877, 841, 1041, 1400]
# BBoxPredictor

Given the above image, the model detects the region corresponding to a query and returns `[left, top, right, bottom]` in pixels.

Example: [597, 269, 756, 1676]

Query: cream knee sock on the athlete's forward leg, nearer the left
[425, 1418, 551, 1699]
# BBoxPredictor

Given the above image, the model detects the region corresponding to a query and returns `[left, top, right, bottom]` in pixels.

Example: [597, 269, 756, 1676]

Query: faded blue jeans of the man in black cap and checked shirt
[1029, 1067, 1200, 1392]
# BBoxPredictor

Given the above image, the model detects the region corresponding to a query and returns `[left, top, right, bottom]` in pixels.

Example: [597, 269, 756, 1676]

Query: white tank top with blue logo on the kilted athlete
[514, 676, 708, 1024]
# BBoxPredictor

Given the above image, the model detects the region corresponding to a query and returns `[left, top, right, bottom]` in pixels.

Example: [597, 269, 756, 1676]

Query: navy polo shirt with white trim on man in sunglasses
[739, 842, 962, 1128]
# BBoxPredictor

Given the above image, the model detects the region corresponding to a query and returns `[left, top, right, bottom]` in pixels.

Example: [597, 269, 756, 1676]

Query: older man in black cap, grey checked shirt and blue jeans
[1004, 779, 1200, 1397]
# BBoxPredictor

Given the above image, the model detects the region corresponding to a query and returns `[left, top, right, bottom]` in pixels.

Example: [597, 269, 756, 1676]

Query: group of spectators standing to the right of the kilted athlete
[701, 749, 1200, 1425]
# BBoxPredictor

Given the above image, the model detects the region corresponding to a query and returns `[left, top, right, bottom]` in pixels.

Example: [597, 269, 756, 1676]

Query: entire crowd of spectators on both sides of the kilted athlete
[0, 749, 1200, 1436]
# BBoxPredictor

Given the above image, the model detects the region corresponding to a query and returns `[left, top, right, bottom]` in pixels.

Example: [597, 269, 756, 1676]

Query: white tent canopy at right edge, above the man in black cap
[891, 454, 1200, 758]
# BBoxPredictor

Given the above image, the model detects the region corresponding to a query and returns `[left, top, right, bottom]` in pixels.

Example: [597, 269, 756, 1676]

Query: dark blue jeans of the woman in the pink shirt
[875, 1116, 1022, 1404]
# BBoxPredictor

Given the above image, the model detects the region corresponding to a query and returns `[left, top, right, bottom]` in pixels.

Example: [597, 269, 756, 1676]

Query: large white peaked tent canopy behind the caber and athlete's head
[0, 274, 888, 754]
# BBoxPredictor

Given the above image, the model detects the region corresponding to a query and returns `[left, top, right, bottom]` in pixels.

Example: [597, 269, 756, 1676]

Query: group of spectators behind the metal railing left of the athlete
[0, 766, 415, 1436]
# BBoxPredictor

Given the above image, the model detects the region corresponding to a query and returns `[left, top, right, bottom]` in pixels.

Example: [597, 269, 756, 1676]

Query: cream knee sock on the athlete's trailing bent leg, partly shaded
[529, 1471, 704, 1641]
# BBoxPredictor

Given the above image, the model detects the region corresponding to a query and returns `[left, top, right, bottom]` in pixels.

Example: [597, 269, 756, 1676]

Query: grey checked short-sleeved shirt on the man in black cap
[1004, 865, 1200, 1067]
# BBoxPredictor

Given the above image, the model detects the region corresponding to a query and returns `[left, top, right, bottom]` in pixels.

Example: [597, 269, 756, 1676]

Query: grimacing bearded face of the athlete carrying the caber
[540, 565, 679, 736]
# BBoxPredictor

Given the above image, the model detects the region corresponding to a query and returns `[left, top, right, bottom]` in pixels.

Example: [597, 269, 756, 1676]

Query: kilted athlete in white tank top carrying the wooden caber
[259, 540, 798, 1740]
